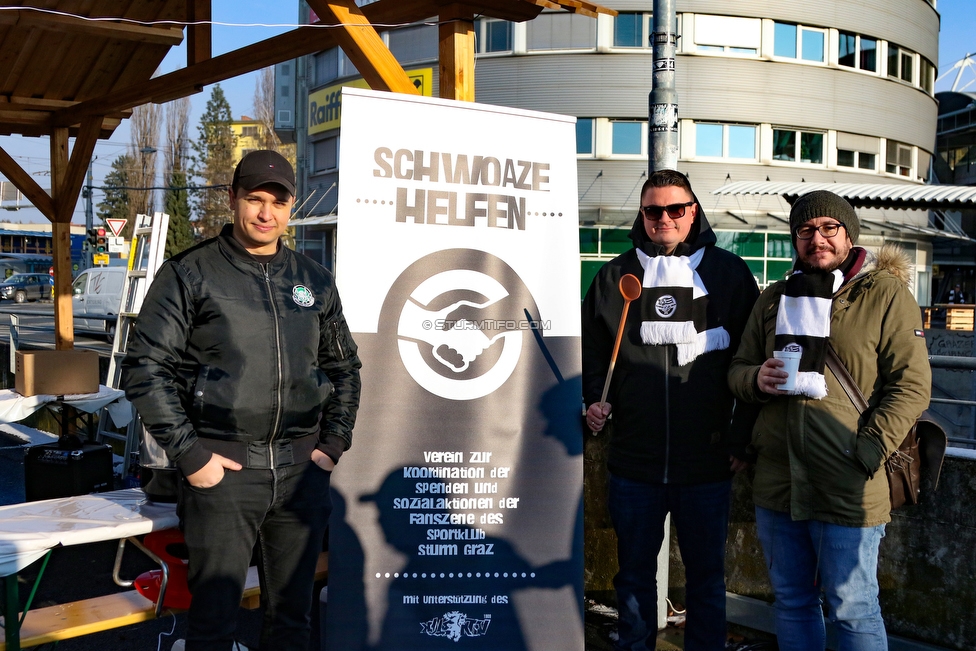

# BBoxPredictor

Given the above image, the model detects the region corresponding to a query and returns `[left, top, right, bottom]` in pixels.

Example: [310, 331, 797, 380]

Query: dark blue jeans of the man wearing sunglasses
[609, 474, 732, 651]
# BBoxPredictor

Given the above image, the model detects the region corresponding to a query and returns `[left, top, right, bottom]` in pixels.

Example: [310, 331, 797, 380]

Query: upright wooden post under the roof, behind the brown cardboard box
[51, 127, 78, 350]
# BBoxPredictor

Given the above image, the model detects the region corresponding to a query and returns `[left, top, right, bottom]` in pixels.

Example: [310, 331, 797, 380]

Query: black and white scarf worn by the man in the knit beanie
[773, 269, 844, 400]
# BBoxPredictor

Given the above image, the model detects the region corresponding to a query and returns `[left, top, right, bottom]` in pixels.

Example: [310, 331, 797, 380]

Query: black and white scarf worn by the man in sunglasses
[637, 247, 729, 366]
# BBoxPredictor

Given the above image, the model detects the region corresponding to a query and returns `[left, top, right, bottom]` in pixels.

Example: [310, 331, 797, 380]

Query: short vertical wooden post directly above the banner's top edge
[437, 4, 475, 102]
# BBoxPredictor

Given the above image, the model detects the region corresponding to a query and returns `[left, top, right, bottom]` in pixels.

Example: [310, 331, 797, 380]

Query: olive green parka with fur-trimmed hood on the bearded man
[729, 245, 932, 527]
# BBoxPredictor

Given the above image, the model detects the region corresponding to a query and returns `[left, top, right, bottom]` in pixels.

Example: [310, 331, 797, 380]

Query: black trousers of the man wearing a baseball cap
[178, 462, 332, 651]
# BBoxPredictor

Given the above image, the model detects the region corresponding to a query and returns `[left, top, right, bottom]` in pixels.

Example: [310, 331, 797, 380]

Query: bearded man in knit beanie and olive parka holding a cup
[729, 191, 932, 651]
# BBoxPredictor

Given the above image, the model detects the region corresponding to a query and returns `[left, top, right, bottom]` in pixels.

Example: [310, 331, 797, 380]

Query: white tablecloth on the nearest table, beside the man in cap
[0, 488, 179, 577]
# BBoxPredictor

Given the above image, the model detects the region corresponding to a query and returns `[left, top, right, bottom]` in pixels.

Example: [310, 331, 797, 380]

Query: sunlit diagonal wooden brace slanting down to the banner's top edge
[308, 0, 418, 95]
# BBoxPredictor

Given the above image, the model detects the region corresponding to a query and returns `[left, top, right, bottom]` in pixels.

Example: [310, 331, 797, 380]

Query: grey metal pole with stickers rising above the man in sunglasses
[647, 0, 678, 174]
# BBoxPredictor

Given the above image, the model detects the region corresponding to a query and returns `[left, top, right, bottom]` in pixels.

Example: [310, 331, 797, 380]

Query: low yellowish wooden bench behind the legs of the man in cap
[0, 552, 329, 651]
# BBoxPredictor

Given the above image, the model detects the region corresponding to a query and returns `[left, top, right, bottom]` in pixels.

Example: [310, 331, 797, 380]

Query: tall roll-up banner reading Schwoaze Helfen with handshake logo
[327, 88, 583, 651]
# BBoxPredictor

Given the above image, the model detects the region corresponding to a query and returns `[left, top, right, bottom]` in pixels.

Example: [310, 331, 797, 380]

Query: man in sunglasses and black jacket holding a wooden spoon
[582, 170, 759, 651]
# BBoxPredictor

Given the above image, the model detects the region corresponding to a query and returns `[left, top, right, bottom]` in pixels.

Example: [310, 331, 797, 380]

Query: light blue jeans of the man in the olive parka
[756, 506, 888, 651]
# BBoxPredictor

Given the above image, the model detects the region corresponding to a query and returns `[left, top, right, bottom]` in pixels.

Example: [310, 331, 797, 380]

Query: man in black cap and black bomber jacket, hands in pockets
[122, 151, 360, 651]
